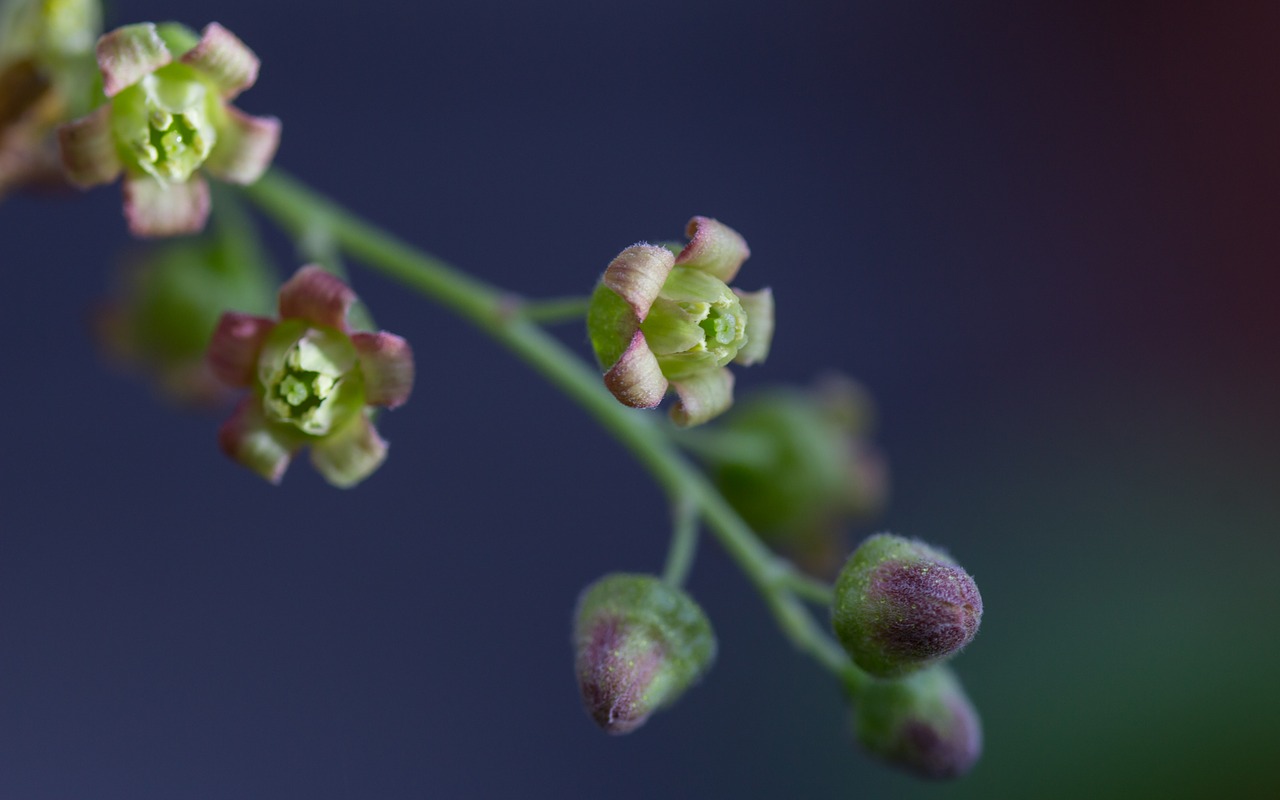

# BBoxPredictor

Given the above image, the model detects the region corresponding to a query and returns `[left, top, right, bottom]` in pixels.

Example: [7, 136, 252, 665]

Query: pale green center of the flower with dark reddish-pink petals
[259, 320, 365, 436]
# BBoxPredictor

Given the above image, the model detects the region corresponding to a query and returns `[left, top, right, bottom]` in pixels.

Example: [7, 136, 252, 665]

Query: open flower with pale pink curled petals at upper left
[58, 22, 280, 237]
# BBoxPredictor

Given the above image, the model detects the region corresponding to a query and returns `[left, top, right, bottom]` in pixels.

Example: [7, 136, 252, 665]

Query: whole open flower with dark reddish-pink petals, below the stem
[209, 265, 413, 488]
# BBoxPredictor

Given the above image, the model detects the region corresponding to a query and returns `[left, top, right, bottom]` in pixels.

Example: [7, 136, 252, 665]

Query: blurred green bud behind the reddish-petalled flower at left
[95, 218, 275, 407]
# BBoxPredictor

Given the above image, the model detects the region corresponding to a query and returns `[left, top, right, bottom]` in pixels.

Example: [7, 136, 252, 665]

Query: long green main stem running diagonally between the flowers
[246, 169, 868, 691]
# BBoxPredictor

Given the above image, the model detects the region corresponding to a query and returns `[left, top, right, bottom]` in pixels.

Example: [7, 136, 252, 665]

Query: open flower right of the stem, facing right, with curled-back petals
[586, 216, 773, 426]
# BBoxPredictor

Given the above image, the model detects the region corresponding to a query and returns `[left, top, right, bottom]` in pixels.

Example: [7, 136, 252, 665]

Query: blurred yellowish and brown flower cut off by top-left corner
[0, 0, 101, 197]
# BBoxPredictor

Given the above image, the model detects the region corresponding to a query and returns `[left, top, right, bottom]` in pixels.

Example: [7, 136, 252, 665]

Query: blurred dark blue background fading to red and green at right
[0, 0, 1280, 800]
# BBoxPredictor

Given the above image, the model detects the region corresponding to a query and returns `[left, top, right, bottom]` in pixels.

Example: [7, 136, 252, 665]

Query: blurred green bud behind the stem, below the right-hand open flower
[682, 376, 888, 576]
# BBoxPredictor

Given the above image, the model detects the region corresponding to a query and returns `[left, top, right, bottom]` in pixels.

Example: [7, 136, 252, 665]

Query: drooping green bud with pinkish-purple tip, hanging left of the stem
[573, 573, 716, 733]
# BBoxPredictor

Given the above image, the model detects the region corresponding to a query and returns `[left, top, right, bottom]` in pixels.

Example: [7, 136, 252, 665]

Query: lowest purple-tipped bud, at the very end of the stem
[854, 667, 982, 780]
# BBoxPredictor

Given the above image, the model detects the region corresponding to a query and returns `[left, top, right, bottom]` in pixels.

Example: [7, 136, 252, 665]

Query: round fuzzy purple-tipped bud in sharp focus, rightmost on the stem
[832, 534, 982, 677]
